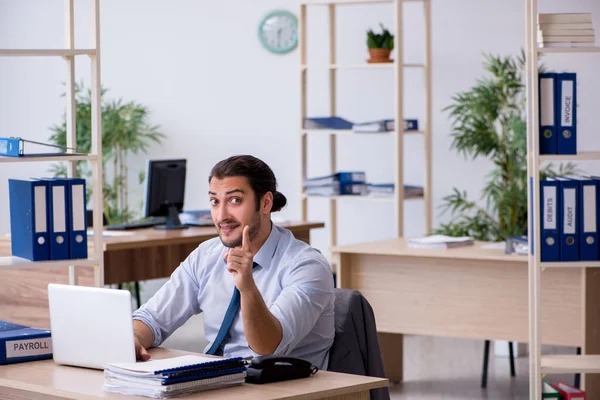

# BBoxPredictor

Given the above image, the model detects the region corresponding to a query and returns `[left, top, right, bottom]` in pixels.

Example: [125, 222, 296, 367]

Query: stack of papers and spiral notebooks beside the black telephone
[103, 355, 246, 399]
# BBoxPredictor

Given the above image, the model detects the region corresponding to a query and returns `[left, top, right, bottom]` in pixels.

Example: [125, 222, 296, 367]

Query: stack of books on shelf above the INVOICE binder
[538, 13, 596, 47]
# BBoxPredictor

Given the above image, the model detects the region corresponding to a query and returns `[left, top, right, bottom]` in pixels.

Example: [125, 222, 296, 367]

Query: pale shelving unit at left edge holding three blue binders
[0, 0, 104, 287]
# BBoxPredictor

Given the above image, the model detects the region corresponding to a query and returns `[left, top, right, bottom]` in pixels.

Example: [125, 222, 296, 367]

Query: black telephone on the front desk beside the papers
[246, 355, 319, 383]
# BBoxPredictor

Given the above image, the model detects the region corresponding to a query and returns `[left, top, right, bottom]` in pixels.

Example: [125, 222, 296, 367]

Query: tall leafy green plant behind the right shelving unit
[434, 51, 580, 242]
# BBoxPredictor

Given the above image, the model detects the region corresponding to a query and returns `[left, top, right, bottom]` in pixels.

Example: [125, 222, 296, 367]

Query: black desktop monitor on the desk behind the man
[144, 159, 187, 229]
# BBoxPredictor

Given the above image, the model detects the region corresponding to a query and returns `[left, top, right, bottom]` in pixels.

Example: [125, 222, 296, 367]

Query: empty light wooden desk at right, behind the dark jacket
[332, 239, 600, 398]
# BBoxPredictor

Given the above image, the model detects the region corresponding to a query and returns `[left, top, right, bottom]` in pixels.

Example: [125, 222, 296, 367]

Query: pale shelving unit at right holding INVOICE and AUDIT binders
[525, 0, 600, 400]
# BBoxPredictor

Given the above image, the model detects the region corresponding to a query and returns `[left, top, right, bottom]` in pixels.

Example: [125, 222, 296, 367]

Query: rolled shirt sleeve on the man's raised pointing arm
[255, 258, 334, 355]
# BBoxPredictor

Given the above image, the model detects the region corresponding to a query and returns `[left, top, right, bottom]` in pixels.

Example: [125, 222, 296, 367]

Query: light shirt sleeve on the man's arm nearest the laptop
[133, 247, 202, 347]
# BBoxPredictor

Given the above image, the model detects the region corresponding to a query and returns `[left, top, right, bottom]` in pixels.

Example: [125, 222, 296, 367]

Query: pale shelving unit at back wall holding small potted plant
[299, 0, 432, 256]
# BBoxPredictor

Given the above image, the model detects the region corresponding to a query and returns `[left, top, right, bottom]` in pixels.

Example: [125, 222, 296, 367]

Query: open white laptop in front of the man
[48, 283, 136, 369]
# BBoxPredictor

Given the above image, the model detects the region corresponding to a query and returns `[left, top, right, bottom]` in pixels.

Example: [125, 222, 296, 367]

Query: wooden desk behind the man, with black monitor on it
[0, 222, 325, 328]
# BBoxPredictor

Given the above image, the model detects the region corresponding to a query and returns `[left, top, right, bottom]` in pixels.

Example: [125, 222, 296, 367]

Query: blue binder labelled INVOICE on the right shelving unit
[557, 73, 577, 154]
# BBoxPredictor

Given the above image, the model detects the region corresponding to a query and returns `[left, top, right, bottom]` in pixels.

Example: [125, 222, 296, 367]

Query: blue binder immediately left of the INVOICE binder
[538, 73, 558, 154]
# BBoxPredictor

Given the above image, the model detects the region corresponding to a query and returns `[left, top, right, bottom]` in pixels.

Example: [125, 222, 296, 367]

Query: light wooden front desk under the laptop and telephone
[0, 348, 388, 400]
